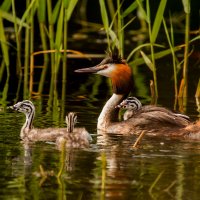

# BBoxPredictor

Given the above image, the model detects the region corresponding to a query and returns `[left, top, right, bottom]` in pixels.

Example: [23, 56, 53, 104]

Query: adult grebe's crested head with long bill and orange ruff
[75, 52, 133, 94]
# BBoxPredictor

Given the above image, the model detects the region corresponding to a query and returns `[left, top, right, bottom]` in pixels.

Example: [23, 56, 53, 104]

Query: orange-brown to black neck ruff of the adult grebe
[110, 64, 133, 94]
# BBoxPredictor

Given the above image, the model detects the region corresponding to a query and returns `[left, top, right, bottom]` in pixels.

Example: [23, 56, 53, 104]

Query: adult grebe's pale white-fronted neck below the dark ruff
[97, 93, 126, 131]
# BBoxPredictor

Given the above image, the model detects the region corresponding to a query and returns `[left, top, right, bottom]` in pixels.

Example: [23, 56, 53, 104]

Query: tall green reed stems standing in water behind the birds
[0, 0, 200, 102]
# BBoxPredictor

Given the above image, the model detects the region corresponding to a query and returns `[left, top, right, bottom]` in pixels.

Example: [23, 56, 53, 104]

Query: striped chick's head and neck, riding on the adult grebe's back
[116, 97, 142, 120]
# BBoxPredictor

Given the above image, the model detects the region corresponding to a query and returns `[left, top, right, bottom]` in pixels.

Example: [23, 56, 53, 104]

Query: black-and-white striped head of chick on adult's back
[116, 97, 142, 111]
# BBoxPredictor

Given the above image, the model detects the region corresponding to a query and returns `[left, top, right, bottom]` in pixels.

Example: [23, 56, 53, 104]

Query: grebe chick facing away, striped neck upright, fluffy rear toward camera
[56, 112, 92, 149]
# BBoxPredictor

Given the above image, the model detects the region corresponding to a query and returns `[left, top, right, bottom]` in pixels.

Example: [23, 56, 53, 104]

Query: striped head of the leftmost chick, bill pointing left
[11, 100, 35, 116]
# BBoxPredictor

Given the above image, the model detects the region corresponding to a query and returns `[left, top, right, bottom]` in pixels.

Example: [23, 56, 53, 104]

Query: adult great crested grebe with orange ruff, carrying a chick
[75, 53, 200, 138]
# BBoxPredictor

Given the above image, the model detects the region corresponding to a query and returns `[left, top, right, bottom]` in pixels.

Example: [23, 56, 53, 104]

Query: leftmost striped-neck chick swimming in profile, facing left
[11, 100, 72, 142]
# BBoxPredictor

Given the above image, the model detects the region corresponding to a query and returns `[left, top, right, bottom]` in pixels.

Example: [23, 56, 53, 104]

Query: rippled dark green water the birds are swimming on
[0, 85, 200, 200]
